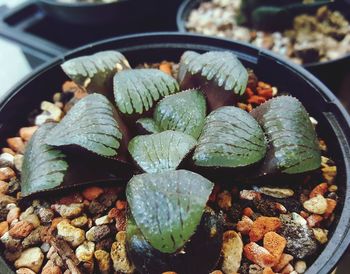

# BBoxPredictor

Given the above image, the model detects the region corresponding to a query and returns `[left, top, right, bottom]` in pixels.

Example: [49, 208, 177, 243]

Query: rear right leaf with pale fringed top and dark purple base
[179, 51, 248, 110]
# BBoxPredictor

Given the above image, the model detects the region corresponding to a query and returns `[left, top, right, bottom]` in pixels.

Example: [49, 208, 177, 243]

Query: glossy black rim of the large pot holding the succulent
[0, 32, 350, 274]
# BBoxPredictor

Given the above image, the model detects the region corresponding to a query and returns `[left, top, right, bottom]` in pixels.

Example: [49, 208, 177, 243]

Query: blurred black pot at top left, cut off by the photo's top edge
[37, 0, 161, 27]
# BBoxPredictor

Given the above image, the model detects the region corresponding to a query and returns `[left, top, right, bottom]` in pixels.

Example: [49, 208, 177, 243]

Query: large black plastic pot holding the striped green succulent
[0, 33, 350, 274]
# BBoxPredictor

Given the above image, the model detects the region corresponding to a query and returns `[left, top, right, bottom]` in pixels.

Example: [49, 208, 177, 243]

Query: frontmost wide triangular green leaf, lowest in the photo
[126, 170, 213, 253]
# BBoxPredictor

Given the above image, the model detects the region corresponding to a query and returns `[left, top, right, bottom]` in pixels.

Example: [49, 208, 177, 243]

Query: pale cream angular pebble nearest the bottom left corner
[15, 247, 44, 273]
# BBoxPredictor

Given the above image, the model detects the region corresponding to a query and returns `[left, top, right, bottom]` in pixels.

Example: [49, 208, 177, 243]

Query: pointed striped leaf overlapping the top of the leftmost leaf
[46, 93, 122, 157]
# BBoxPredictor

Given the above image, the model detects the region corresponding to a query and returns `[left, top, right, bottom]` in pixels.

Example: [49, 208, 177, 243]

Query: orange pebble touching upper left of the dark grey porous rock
[249, 216, 281, 242]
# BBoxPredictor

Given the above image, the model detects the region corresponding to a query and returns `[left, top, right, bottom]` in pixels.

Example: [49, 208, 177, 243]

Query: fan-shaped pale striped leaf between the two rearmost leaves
[114, 69, 179, 114]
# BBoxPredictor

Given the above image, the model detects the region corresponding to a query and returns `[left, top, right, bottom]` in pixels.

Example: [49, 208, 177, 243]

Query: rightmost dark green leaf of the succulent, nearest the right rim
[251, 96, 321, 174]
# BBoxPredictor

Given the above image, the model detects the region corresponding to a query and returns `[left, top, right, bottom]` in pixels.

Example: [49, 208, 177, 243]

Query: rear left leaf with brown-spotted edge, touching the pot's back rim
[61, 50, 130, 96]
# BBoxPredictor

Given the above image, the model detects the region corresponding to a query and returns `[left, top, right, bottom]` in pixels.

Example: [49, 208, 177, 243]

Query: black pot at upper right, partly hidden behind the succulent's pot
[176, 0, 350, 94]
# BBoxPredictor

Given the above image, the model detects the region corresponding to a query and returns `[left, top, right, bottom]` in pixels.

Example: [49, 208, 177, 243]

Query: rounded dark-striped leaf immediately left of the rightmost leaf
[193, 107, 266, 167]
